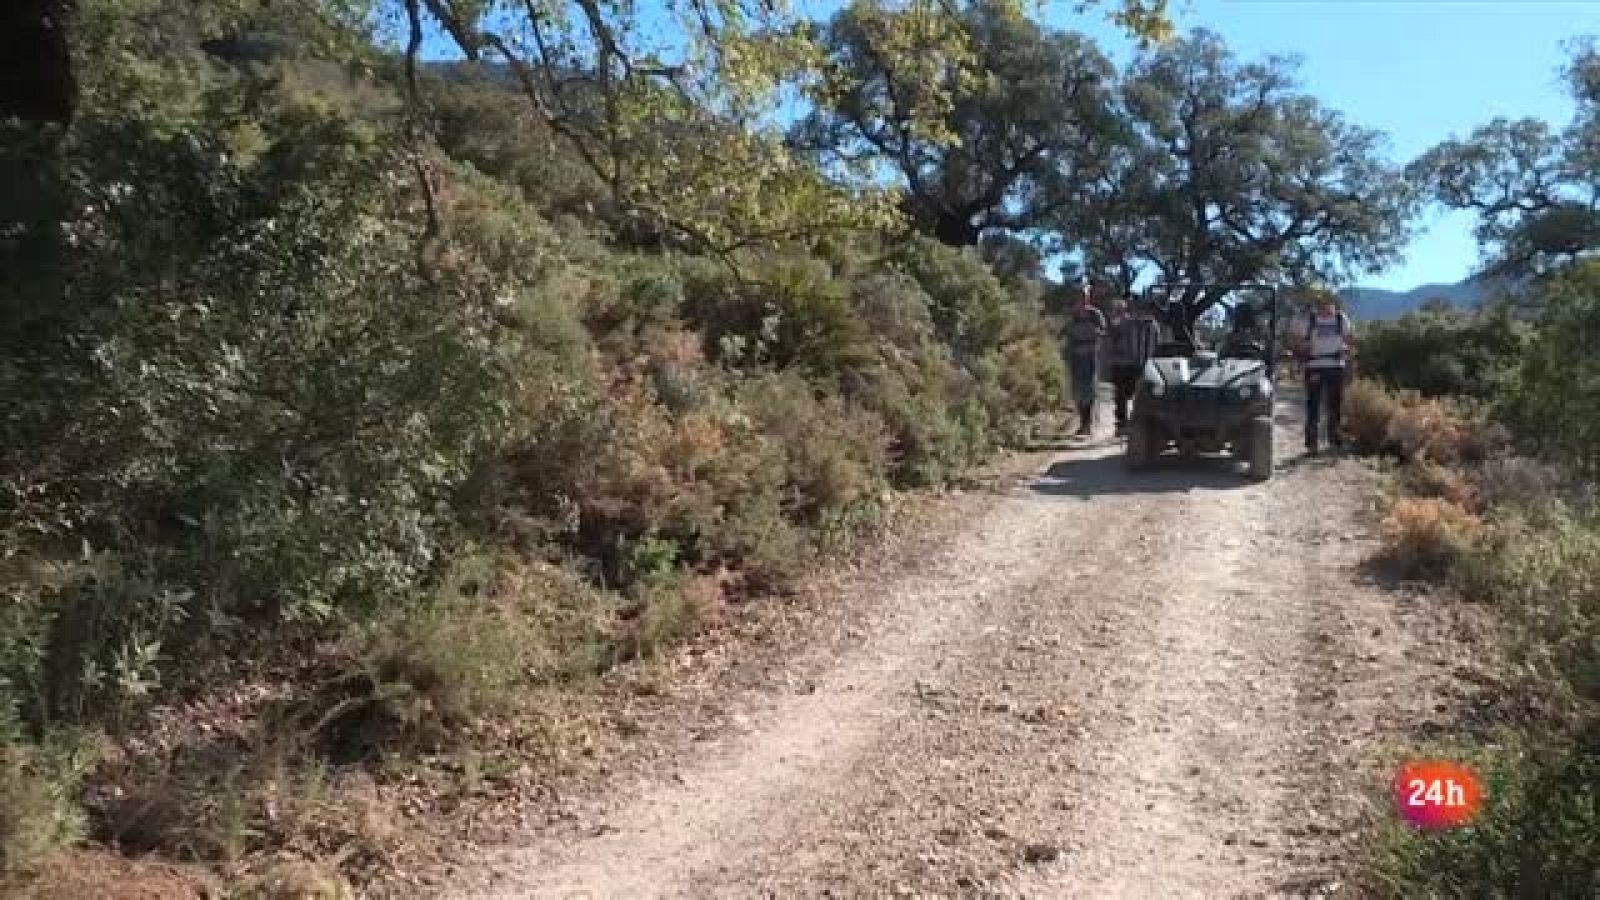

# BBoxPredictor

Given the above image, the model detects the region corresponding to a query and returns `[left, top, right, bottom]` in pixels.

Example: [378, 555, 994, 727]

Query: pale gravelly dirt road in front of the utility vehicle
[453, 400, 1484, 897]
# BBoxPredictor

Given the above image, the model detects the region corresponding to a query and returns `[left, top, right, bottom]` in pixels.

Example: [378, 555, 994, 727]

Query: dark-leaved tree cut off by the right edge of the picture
[1408, 42, 1600, 277]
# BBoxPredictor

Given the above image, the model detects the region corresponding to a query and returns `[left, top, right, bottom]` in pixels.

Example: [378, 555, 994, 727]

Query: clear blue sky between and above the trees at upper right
[1043, 0, 1600, 290]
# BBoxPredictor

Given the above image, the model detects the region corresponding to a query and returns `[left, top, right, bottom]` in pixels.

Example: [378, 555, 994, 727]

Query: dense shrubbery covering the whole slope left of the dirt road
[0, 5, 1062, 870]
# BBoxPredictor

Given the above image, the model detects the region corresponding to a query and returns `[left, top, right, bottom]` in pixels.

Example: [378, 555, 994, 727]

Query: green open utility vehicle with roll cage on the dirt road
[1125, 283, 1278, 480]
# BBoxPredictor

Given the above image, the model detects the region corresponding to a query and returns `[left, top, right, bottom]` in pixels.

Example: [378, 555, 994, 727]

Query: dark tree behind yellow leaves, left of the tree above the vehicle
[795, 0, 1118, 247]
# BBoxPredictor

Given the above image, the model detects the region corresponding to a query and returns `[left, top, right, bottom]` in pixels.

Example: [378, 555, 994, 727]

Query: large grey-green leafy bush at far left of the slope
[0, 87, 541, 733]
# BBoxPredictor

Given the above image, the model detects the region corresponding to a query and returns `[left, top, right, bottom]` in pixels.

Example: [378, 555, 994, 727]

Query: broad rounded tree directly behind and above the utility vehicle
[1058, 30, 1411, 320]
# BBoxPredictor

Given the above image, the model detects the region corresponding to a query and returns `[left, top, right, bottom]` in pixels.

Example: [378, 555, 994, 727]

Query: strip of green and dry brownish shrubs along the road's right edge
[1346, 285, 1600, 897]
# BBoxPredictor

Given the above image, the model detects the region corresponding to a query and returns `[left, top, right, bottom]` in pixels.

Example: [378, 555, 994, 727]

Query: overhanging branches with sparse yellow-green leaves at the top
[400, 0, 1166, 261]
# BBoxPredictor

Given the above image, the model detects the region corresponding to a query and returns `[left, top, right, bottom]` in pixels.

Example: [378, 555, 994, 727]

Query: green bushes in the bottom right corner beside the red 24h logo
[1374, 490, 1600, 897]
